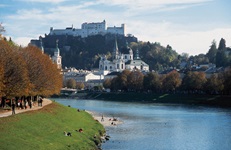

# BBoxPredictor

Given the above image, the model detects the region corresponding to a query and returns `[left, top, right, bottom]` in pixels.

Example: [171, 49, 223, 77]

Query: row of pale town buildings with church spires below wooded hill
[40, 28, 149, 89]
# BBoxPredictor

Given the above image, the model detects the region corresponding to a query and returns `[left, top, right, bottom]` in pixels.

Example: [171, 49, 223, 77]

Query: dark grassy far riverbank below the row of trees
[82, 92, 231, 107]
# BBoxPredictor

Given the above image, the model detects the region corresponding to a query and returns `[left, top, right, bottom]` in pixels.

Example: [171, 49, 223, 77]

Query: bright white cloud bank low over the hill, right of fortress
[122, 20, 231, 55]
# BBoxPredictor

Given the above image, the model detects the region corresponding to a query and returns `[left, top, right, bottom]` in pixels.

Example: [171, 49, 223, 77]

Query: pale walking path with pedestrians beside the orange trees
[0, 98, 52, 118]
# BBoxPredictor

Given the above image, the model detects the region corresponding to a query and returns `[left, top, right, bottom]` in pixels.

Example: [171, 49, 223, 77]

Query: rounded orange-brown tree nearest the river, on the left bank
[20, 45, 62, 96]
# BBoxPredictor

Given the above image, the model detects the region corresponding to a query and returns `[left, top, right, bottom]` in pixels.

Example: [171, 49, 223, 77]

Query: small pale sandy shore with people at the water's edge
[87, 111, 123, 127]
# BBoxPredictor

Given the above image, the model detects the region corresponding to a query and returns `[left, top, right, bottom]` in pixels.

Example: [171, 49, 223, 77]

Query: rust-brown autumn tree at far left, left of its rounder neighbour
[0, 40, 29, 98]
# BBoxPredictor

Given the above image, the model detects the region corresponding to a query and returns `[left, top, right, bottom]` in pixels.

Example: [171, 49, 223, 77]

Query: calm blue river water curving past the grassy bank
[55, 99, 231, 150]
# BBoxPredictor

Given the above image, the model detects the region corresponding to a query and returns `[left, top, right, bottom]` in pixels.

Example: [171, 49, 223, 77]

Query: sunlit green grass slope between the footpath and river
[0, 102, 105, 150]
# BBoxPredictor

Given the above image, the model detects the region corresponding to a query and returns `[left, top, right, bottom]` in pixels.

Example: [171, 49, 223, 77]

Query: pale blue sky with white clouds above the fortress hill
[0, 0, 231, 55]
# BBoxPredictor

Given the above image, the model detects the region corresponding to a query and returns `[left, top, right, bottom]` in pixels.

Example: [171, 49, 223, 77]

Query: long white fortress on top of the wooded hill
[49, 20, 126, 38]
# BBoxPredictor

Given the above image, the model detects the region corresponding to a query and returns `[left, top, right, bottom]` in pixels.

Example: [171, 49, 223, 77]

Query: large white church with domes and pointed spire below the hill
[99, 40, 149, 75]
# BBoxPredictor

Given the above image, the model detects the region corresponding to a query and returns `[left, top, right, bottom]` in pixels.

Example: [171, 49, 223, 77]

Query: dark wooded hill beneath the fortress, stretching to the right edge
[31, 34, 231, 71]
